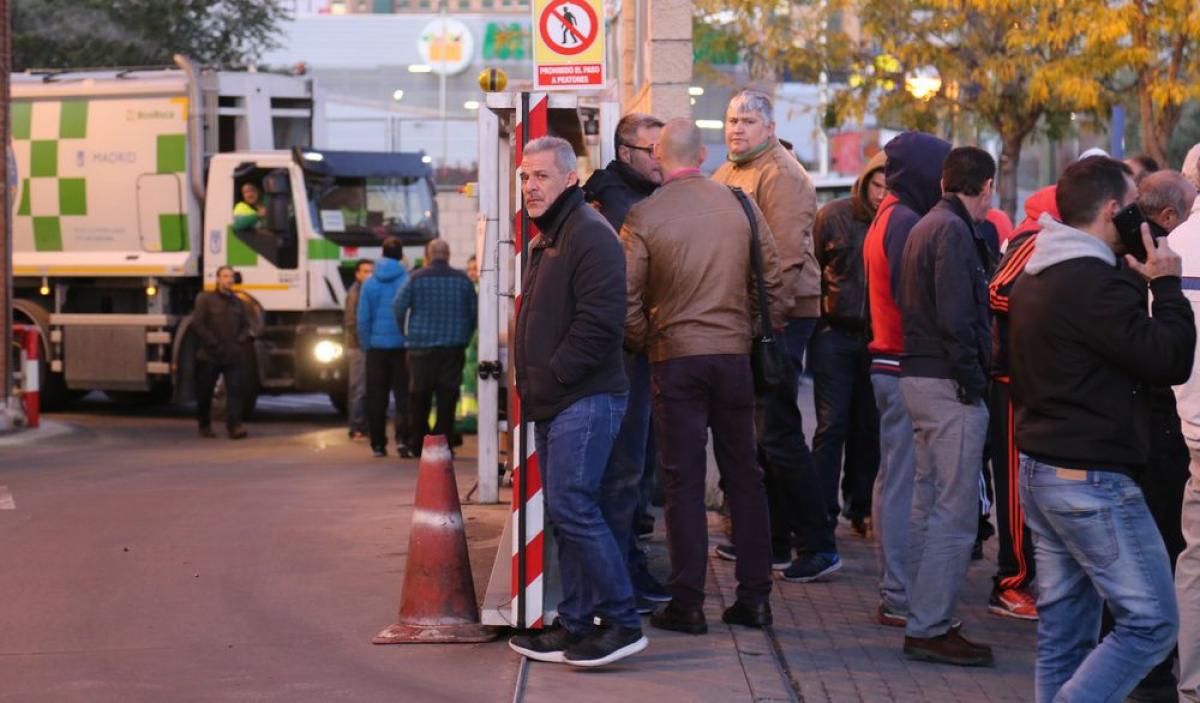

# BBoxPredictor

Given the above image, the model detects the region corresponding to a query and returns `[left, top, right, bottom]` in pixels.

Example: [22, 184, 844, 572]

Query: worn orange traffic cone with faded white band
[372, 434, 496, 644]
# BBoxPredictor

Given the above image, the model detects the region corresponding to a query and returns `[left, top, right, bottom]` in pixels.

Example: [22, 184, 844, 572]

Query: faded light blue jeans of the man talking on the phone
[1020, 455, 1180, 703]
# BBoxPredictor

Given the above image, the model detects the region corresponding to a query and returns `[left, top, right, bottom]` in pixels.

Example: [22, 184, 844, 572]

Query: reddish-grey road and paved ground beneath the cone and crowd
[0, 396, 1036, 703]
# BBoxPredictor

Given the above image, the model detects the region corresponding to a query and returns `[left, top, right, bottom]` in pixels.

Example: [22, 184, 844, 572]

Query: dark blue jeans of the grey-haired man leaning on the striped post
[534, 393, 641, 633]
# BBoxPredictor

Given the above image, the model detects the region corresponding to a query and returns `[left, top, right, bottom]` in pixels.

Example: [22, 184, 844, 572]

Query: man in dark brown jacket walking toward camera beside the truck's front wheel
[191, 266, 250, 439]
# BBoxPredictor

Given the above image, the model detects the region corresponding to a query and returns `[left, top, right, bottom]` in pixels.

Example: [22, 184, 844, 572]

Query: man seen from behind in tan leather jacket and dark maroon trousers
[620, 119, 785, 635]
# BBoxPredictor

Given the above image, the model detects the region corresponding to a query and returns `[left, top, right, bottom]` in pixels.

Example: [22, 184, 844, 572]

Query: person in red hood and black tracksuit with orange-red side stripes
[988, 186, 1058, 620]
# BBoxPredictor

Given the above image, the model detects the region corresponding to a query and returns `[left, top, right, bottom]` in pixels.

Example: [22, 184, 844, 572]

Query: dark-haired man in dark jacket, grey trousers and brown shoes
[896, 146, 996, 666]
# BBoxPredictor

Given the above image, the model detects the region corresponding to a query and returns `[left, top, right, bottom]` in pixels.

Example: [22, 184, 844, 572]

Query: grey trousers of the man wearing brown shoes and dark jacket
[900, 378, 988, 638]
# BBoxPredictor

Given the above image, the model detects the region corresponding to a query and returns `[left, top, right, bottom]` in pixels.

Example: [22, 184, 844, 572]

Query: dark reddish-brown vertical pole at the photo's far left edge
[0, 0, 13, 405]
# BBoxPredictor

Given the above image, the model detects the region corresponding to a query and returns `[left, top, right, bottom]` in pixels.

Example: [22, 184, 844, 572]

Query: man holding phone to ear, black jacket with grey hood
[1009, 156, 1195, 701]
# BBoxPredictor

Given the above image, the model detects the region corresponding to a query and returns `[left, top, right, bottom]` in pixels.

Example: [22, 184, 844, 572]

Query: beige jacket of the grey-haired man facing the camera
[713, 137, 821, 318]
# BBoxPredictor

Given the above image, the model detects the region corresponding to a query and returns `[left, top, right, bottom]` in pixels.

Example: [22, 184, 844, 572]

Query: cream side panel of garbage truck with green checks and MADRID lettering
[11, 98, 190, 253]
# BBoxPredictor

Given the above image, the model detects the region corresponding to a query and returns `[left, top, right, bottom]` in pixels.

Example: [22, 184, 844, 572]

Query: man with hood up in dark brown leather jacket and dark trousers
[809, 151, 888, 536]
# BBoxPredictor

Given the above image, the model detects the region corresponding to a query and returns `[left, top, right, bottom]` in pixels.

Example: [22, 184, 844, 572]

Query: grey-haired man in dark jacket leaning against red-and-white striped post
[509, 137, 647, 666]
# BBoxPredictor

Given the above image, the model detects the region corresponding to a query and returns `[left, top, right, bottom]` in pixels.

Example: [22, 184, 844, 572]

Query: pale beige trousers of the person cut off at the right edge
[1175, 467, 1200, 702]
